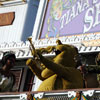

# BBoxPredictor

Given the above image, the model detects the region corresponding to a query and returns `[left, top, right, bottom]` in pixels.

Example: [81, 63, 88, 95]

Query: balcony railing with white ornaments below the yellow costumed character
[0, 88, 100, 100]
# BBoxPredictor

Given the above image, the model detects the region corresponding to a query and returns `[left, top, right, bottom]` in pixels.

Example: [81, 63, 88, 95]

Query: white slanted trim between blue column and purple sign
[32, 0, 48, 41]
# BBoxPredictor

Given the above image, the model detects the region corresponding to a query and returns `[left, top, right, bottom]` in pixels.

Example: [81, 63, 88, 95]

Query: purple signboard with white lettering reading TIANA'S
[40, 0, 100, 39]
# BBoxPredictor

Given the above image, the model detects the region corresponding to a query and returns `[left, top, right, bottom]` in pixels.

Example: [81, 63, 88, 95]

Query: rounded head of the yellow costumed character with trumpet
[53, 40, 78, 67]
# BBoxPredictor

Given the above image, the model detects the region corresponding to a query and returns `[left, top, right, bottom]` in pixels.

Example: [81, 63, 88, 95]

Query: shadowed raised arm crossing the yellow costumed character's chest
[39, 54, 80, 81]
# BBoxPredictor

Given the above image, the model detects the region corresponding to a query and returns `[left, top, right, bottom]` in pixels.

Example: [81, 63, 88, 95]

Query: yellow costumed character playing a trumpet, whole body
[26, 40, 83, 91]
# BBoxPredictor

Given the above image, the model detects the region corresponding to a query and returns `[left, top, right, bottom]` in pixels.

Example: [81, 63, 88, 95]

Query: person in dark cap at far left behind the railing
[0, 52, 16, 92]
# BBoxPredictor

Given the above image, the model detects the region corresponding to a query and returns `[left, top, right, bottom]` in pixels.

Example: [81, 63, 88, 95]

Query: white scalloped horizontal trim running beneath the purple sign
[0, 36, 100, 59]
